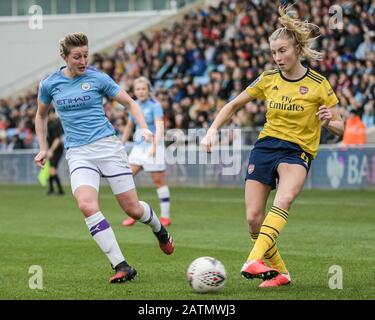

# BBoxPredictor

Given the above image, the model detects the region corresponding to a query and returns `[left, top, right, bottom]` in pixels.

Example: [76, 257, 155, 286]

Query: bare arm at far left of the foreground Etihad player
[34, 100, 49, 167]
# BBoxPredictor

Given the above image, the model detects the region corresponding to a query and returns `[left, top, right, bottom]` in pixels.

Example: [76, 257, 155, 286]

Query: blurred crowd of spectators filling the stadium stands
[0, 0, 375, 151]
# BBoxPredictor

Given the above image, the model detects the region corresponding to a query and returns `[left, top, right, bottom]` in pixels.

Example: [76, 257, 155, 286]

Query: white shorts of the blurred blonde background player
[129, 143, 165, 172]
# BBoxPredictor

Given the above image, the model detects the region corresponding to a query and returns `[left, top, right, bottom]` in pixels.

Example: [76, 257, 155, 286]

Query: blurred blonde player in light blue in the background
[121, 77, 171, 227]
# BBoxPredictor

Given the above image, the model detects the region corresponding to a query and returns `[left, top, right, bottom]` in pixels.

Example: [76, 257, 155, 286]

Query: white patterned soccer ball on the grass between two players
[187, 257, 227, 293]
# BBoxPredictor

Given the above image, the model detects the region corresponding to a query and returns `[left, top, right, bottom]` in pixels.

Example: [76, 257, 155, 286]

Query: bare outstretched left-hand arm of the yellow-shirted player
[201, 90, 252, 152]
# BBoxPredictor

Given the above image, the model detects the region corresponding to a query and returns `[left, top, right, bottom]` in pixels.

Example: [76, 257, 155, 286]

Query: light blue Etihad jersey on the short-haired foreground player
[38, 67, 120, 148]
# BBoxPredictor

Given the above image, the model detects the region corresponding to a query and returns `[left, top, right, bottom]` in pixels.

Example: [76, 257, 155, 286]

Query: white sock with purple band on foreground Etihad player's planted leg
[85, 211, 125, 267]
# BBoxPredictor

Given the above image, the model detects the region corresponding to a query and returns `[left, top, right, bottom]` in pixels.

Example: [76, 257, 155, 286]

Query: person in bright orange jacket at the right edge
[342, 109, 366, 145]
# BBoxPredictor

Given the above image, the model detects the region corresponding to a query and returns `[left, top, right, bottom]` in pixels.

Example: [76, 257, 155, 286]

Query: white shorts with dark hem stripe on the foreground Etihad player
[65, 136, 135, 194]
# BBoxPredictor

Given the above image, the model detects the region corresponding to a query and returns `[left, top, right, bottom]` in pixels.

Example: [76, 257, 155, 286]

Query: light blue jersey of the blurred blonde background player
[129, 98, 163, 144]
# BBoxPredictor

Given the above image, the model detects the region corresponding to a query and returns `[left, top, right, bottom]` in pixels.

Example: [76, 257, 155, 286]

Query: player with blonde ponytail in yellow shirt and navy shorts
[202, 8, 344, 288]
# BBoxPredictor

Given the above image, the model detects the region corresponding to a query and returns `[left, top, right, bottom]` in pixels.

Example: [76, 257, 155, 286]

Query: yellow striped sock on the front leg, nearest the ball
[247, 206, 288, 260]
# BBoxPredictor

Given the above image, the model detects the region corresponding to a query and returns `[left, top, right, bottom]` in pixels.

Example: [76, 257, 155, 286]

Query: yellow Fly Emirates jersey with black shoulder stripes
[246, 69, 338, 158]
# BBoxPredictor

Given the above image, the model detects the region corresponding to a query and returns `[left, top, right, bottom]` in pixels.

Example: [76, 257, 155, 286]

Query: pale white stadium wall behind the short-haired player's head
[0, 10, 175, 98]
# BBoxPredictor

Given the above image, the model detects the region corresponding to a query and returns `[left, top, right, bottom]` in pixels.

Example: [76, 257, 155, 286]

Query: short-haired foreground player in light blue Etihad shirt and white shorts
[35, 33, 174, 283]
